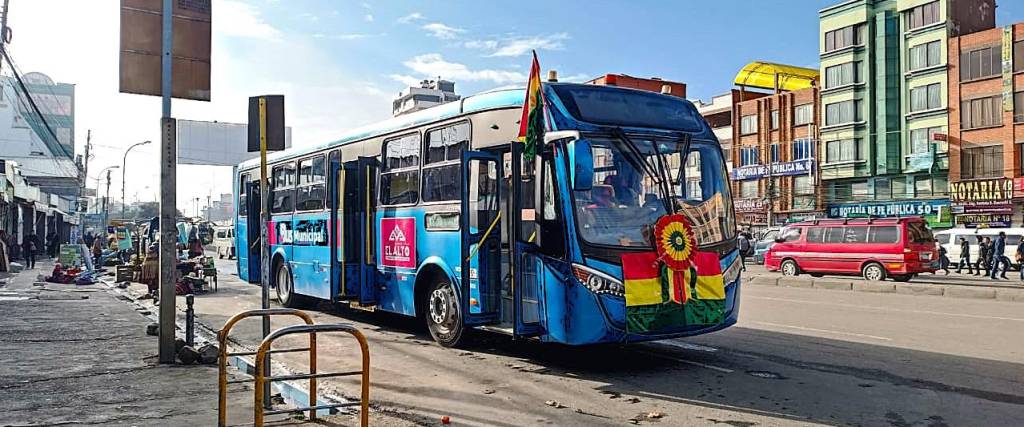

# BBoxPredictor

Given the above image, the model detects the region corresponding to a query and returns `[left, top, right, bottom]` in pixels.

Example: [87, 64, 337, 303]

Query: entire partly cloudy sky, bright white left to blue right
[8, 0, 1024, 204]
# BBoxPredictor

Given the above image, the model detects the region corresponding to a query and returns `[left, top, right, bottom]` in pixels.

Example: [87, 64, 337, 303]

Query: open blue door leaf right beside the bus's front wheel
[459, 152, 502, 325]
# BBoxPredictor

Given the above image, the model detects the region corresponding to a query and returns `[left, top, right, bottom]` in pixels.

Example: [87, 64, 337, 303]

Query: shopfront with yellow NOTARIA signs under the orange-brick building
[949, 178, 1015, 228]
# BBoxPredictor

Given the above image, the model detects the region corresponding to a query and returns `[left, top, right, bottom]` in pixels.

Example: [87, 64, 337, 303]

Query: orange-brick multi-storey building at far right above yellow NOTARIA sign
[936, 24, 1024, 227]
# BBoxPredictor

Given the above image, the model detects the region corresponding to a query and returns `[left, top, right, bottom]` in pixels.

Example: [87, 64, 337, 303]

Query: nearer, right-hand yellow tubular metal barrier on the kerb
[253, 324, 370, 427]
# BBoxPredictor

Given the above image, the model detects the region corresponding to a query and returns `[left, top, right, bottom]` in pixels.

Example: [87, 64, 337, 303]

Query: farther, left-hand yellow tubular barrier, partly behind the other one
[217, 308, 316, 427]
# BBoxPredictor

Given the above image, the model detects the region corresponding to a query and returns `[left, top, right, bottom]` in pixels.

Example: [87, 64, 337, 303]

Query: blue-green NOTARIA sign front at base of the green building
[827, 199, 953, 228]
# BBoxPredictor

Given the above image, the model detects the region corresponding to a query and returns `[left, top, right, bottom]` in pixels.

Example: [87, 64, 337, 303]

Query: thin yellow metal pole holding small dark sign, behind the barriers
[259, 97, 270, 408]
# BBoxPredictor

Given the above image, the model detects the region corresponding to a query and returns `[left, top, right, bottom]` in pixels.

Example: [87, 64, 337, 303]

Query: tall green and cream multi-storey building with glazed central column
[818, 0, 995, 226]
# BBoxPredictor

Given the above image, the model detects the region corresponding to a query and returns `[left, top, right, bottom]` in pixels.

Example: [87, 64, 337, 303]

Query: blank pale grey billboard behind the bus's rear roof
[177, 120, 292, 166]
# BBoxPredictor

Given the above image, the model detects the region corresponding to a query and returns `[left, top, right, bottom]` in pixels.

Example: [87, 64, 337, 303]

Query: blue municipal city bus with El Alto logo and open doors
[234, 82, 740, 346]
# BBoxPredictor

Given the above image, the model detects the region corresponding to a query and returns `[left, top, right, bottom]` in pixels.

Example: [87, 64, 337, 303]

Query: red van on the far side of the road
[765, 217, 938, 282]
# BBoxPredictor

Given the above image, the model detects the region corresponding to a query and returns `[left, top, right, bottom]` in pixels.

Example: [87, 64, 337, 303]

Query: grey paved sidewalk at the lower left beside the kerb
[0, 261, 335, 426]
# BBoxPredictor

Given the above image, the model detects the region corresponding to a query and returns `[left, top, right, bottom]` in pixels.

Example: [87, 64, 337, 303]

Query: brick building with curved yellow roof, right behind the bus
[730, 62, 822, 227]
